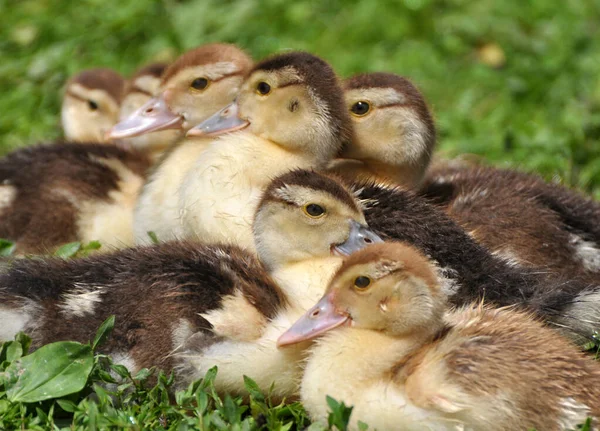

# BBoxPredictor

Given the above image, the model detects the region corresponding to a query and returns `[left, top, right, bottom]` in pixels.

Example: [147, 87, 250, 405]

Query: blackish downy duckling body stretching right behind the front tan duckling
[358, 184, 600, 343]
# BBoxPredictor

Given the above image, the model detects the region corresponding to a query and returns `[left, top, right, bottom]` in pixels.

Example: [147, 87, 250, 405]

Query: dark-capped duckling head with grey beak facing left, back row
[188, 52, 352, 165]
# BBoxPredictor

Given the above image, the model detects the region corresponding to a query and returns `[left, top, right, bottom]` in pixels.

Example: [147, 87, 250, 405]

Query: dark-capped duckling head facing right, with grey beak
[253, 170, 382, 270]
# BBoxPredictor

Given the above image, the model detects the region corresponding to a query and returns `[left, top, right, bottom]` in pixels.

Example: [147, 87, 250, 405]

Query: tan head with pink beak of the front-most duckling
[278, 243, 446, 346]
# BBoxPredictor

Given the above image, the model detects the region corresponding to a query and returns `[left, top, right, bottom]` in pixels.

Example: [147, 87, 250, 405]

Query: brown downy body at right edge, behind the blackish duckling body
[420, 166, 600, 282]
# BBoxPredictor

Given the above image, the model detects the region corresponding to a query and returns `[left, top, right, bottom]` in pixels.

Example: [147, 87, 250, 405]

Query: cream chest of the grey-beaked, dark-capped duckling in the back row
[179, 135, 310, 249]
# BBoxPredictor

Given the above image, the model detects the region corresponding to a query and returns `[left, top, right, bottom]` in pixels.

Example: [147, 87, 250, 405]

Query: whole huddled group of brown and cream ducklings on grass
[0, 44, 600, 430]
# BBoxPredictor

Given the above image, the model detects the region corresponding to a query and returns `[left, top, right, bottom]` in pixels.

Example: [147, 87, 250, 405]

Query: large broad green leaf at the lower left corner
[6, 341, 94, 403]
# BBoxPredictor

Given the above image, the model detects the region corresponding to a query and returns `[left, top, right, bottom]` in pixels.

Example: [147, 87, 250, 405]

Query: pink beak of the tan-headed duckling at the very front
[277, 294, 351, 347]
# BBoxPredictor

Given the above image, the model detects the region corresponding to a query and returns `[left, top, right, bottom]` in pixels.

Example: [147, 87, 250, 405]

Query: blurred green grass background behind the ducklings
[0, 0, 600, 198]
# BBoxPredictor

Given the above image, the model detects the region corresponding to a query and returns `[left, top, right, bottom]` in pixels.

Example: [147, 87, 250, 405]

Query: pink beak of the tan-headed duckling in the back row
[108, 96, 183, 139]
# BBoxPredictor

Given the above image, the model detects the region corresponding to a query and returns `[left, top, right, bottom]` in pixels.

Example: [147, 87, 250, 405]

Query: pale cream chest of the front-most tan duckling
[301, 334, 465, 430]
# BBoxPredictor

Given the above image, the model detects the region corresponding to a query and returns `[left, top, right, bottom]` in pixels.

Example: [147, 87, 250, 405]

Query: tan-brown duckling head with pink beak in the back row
[110, 43, 252, 139]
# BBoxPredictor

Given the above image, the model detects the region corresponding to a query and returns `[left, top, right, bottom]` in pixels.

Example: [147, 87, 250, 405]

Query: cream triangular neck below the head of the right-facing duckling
[271, 256, 343, 310]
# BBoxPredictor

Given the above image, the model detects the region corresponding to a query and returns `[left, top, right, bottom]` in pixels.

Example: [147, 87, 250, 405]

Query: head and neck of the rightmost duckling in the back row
[329, 73, 436, 188]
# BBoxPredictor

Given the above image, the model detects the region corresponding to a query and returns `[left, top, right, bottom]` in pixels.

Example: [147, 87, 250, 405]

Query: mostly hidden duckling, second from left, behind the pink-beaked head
[115, 63, 180, 165]
